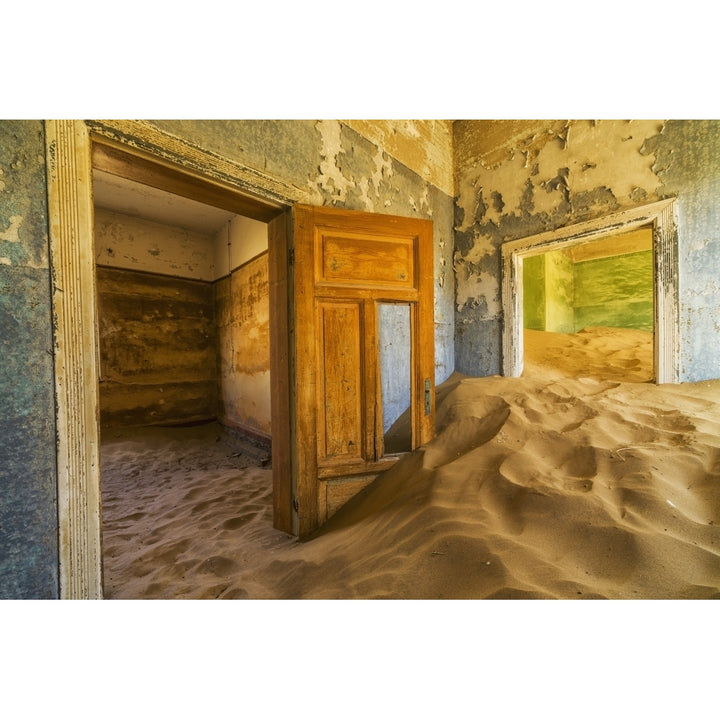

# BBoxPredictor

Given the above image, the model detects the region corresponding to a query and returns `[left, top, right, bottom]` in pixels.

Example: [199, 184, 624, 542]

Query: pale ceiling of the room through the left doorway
[93, 169, 235, 235]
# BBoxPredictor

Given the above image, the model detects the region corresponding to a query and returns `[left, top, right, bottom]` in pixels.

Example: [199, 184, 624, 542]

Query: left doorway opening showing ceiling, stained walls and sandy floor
[93, 168, 282, 597]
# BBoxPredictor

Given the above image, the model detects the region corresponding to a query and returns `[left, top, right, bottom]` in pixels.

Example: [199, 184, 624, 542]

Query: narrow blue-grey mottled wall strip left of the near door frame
[0, 120, 59, 598]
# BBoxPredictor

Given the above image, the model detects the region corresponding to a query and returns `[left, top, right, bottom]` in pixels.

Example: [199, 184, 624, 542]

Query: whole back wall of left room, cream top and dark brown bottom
[95, 208, 218, 427]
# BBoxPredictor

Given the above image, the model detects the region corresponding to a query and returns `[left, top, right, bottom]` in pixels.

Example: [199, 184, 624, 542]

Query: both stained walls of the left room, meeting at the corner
[95, 207, 270, 439]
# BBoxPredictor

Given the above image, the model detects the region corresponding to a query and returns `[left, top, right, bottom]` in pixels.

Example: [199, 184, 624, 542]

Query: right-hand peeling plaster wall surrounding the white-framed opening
[453, 120, 720, 381]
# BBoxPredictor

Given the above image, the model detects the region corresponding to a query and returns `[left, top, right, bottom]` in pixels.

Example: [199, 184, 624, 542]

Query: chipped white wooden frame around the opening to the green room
[502, 199, 680, 383]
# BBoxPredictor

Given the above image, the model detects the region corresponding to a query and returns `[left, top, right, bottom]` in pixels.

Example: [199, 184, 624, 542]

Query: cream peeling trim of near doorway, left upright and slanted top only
[45, 120, 307, 599]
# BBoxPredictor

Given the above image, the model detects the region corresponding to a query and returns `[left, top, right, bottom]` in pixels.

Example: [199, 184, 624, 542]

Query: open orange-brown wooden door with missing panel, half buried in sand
[284, 206, 435, 538]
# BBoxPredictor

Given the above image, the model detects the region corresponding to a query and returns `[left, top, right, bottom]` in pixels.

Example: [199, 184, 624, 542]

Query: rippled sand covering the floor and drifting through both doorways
[102, 328, 720, 598]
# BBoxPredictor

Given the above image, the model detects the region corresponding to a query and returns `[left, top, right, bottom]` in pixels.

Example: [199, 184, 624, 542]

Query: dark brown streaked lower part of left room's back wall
[97, 267, 218, 427]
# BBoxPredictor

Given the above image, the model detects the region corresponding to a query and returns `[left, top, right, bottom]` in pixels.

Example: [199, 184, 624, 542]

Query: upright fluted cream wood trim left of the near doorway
[45, 120, 102, 599]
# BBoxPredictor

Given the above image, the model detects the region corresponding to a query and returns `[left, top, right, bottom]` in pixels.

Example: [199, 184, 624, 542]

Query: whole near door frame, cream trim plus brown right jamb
[45, 120, 307, 599]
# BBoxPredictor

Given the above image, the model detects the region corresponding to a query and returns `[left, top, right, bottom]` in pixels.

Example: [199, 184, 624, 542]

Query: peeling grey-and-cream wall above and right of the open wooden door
[152, 120, 455, 382]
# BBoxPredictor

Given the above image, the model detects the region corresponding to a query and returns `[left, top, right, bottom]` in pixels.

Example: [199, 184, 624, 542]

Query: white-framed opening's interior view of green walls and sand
[522, 225, 654, 382]
